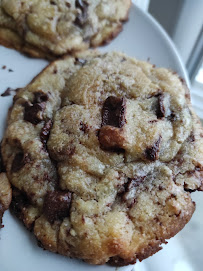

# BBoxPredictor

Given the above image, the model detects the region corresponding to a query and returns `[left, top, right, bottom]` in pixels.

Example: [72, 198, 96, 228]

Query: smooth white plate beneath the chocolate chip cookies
[0, 5, 197, 271]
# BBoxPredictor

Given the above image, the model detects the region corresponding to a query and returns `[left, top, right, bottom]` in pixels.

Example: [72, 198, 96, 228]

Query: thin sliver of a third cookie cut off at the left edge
[0, 150, 12, 229]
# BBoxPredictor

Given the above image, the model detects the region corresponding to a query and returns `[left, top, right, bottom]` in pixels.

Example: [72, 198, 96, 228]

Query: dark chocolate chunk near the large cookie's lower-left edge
[43, 191, 71, 223]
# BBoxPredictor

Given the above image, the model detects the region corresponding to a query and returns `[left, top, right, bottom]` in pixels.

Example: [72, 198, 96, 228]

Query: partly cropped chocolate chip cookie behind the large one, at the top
[0, 0, 131, 58]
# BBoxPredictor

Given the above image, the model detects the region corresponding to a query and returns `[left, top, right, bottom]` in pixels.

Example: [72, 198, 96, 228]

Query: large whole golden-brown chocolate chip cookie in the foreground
[2, 52, 203, 265]
